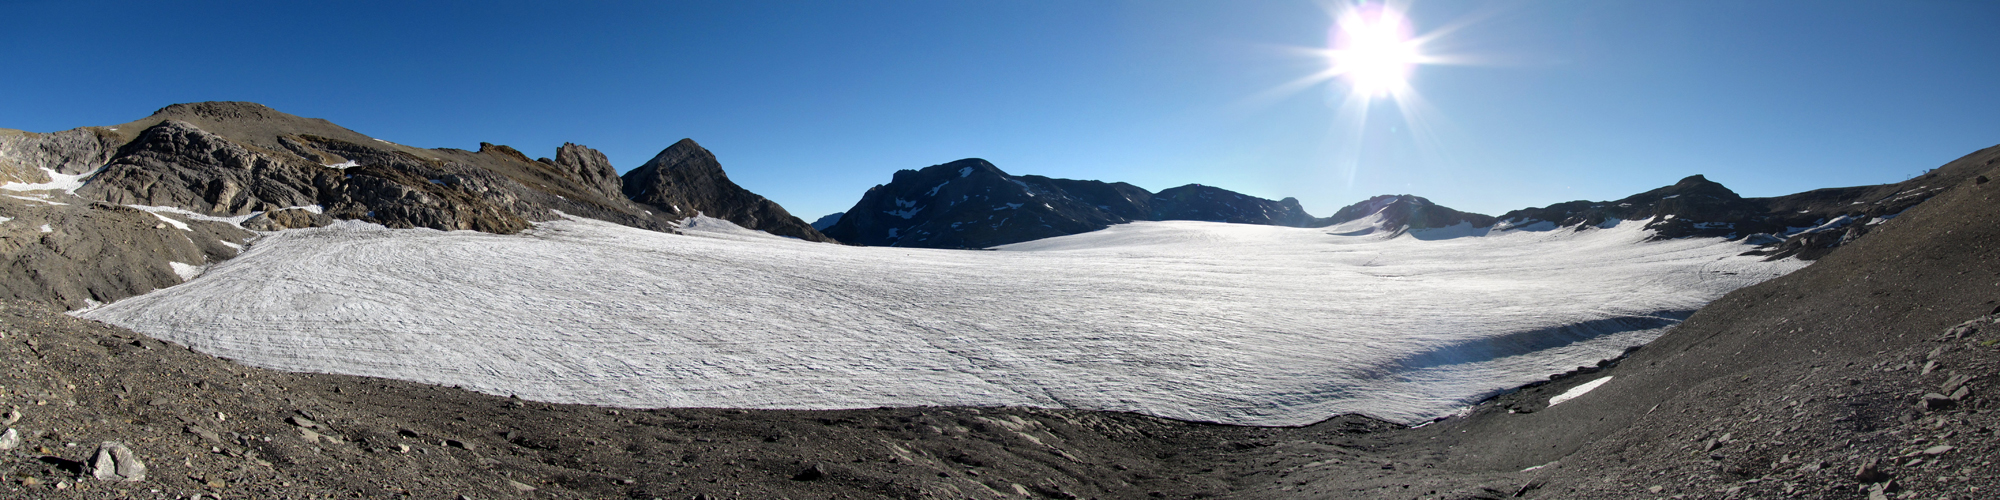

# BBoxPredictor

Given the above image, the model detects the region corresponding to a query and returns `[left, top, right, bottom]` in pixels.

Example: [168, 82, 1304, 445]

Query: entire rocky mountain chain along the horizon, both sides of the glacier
[0, 102, 1964, 308]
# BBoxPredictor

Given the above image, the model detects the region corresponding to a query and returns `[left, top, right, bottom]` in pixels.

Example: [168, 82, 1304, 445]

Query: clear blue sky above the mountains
[0, 0, 2000, 220]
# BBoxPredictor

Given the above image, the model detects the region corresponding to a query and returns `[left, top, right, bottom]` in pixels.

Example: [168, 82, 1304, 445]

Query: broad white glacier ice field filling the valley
[84, 220, 1804, 424]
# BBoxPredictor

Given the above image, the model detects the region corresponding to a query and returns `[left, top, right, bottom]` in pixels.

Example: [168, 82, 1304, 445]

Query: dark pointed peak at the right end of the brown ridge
[624, 138, 832, 242]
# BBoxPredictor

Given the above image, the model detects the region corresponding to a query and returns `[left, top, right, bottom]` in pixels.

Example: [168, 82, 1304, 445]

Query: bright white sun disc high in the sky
[1326, 4, 1424, 98]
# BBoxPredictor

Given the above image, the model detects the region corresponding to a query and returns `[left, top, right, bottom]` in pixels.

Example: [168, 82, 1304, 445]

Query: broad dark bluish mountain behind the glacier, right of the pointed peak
[826, 158, 1312, 248]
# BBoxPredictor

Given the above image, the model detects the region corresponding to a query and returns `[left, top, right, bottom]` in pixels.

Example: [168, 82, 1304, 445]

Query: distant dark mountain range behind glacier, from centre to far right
[814, 158, 1964, 258]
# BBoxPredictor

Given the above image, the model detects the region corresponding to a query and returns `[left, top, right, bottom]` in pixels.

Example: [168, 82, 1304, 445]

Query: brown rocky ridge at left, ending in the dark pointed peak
[0, 102, 826, 308]
